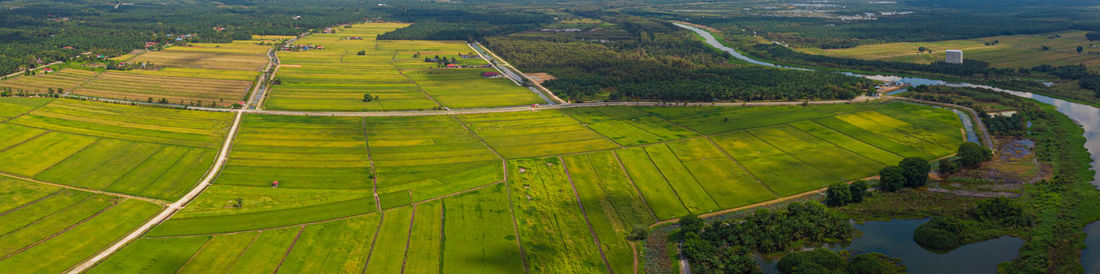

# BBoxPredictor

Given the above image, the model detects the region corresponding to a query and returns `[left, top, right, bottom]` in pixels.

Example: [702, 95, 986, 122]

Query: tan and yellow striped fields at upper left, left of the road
[0, 37, 277, 107]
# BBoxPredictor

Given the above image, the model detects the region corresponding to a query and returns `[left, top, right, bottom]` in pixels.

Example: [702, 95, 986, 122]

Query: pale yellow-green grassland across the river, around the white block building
[799, 31, 1100, 68]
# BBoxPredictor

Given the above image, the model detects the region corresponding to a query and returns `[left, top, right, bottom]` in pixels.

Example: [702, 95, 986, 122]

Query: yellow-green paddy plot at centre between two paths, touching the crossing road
[364, 116, 504, 204]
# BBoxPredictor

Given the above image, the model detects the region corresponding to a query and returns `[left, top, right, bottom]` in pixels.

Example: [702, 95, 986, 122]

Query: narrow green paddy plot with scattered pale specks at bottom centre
[508, 158, 607, 273]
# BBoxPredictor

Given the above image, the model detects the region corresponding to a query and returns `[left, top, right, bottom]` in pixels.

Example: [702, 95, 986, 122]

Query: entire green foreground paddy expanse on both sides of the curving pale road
[0, 98, 964, 273]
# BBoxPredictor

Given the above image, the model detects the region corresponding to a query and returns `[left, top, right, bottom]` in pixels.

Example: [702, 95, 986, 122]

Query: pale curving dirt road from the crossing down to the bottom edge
[66, 107, 244, 274]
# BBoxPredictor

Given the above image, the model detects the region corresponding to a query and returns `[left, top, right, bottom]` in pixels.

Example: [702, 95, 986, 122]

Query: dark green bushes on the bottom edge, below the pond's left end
[776, 249, 905, 274]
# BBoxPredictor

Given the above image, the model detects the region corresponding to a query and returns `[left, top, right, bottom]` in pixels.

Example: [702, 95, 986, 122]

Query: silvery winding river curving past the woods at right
[673, 23, 1100, 273]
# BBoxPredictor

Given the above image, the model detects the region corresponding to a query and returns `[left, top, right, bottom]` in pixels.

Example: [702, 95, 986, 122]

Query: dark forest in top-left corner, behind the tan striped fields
[0, 0, 384, 74]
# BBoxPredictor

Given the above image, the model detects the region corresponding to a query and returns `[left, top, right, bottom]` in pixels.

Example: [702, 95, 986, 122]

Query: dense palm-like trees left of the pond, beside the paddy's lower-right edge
[671, 202, 853, 273]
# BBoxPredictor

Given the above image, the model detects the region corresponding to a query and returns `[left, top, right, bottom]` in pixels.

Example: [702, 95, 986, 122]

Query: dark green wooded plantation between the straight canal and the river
[485, 15, 873, 101]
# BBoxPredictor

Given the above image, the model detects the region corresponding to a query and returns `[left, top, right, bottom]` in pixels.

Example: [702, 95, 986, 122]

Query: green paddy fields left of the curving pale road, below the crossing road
[0, 98, 229, 273]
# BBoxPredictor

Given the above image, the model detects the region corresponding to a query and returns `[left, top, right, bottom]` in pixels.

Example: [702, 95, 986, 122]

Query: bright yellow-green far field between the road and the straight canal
[265, 23, 542, 111]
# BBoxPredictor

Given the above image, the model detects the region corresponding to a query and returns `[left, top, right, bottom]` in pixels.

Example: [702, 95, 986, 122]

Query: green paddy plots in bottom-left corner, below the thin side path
[0, 177, 160, 273]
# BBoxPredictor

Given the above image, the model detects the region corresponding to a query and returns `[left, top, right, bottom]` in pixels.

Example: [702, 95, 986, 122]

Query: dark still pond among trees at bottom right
[757, 219, 1024, 274]
